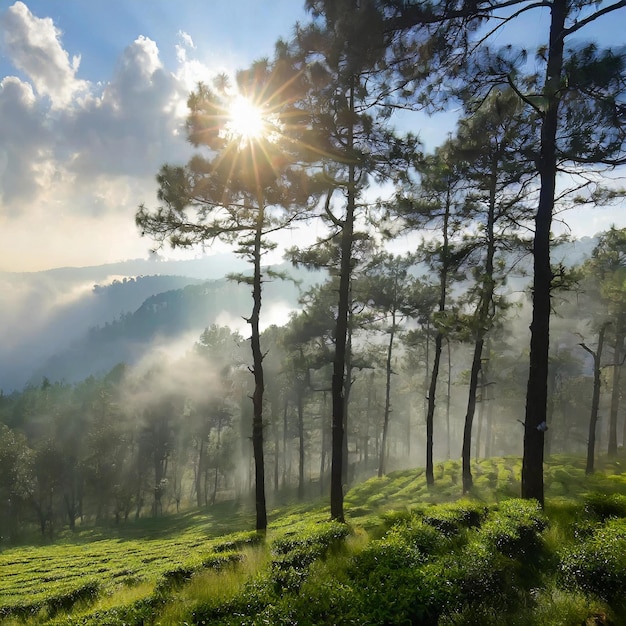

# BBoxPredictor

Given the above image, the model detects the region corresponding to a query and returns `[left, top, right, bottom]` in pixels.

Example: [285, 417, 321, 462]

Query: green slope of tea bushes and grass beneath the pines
[0, 457, 626, 625]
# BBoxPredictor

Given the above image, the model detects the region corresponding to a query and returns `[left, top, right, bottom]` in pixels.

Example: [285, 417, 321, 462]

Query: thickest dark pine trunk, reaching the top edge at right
[521, 0, 568, 506]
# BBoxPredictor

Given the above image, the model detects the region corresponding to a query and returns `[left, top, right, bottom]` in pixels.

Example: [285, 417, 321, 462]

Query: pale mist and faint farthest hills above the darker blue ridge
[0, 254, 247, 391]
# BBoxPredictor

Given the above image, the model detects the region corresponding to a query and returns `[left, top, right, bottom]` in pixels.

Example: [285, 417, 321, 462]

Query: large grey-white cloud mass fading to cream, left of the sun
[0, 2, 215, 271]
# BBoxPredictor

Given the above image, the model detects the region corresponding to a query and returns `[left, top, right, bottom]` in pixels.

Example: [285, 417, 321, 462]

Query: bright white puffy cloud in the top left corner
[0, 2, 87, 109]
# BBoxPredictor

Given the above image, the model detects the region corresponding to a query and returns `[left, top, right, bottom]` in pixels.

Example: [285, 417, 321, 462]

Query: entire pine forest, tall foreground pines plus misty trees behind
[0, 0, 626, 538]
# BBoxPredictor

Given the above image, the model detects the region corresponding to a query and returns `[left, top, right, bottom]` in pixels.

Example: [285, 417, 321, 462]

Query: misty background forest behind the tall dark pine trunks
[0, 227, 626, 541]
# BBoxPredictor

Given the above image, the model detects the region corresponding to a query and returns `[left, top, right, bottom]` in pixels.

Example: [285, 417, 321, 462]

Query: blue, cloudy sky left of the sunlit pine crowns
[0, 0, 626, 272]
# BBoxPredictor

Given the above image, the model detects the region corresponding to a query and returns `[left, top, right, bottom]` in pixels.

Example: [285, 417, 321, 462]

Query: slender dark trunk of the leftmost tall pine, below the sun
[248, 205, 267, 533]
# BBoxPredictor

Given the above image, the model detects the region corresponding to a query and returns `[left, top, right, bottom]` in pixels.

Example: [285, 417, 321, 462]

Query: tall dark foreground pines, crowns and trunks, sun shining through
[137, 0, 626, 530]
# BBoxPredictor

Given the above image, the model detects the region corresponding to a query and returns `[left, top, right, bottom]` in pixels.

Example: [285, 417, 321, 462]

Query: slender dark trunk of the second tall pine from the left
[330, 79, 356, 522]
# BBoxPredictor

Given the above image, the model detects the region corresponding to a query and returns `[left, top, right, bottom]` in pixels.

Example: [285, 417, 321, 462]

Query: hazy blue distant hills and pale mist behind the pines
[0, 237, 597, 392]
